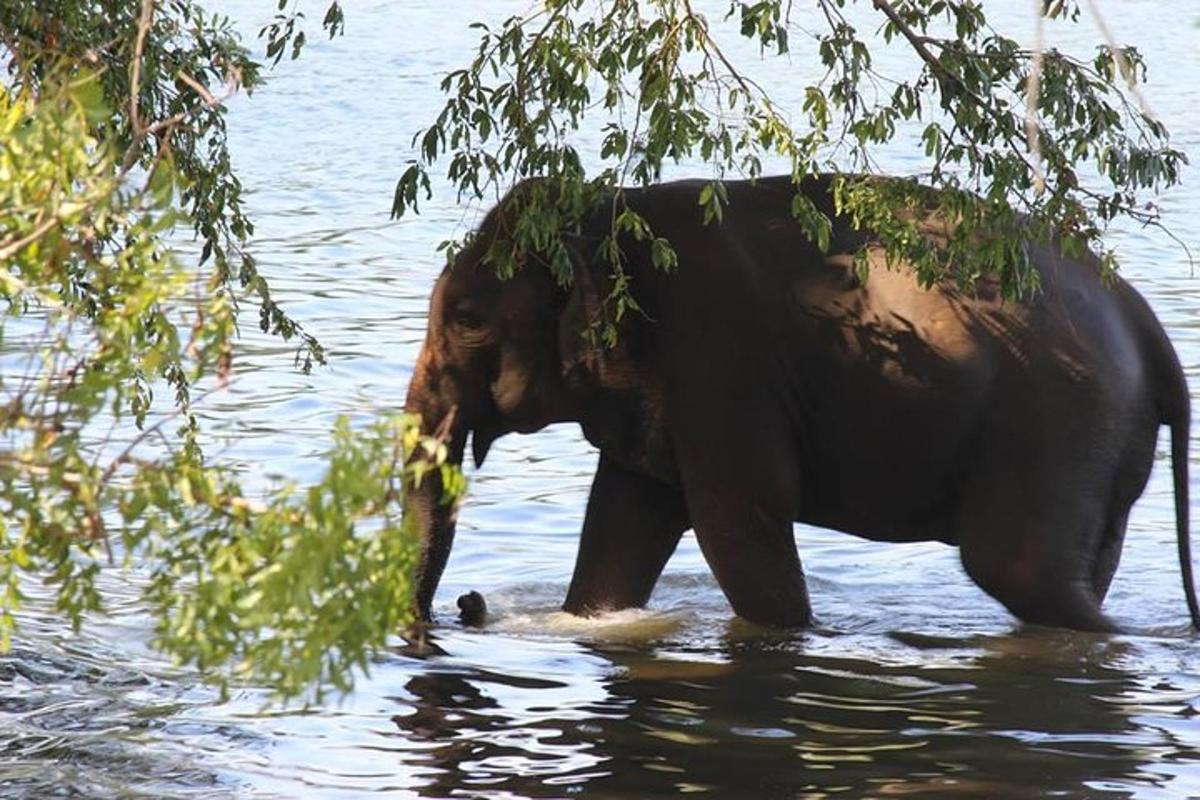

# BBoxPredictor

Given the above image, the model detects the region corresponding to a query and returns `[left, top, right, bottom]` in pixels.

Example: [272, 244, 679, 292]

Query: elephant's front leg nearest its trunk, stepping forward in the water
[563, 455, 689, 615]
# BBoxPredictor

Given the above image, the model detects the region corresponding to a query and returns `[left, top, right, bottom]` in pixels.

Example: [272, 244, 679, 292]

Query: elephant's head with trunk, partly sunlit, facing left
[404, 211, 609, 618]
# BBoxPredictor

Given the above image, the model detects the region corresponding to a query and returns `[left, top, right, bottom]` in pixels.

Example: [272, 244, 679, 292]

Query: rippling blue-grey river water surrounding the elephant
[0, 0, 1200, 799]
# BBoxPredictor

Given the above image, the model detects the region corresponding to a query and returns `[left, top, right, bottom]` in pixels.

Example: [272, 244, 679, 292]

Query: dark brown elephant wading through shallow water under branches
[406, 175, 1200, 632]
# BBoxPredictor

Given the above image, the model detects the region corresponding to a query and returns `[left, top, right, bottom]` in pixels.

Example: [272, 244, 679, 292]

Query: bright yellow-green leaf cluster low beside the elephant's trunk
[137, 415, 464, 699]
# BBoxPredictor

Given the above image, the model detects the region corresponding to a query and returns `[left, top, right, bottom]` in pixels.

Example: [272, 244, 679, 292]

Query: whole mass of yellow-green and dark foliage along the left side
[0, 0, 462, 697]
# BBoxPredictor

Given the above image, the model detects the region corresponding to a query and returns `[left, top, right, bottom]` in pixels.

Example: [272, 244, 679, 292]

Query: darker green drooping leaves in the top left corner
[0, 0, 324, 369]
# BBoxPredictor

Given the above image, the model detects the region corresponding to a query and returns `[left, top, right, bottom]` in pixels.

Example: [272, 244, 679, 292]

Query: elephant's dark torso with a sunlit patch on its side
[609, 179, 1160, 541]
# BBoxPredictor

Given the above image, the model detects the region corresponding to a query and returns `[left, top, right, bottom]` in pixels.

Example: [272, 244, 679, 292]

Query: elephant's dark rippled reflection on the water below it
[395, 631, 1200, 798]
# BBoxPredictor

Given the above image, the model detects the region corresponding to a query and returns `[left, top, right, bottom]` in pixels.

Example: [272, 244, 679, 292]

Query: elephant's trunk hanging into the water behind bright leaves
[404, 345, 467, 620]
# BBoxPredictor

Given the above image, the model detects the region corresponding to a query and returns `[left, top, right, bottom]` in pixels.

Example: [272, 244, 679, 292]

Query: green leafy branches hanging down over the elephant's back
[394, 0, 1184, 342]
